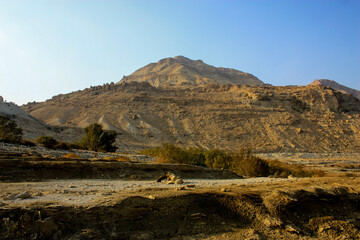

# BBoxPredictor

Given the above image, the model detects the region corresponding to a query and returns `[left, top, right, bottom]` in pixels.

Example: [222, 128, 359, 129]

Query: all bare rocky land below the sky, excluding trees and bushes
[0, 57, 360, 240]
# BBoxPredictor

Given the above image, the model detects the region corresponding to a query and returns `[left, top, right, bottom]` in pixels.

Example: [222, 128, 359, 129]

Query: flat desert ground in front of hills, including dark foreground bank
[0, 144, 360, 239]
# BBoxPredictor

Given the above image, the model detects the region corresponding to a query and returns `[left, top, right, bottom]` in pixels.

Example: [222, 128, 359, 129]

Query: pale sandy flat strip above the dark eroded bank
[0, 177, 299, 207]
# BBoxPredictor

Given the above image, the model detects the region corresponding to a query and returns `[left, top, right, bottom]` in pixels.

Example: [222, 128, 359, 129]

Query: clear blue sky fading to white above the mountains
[0, 0, 360, 104]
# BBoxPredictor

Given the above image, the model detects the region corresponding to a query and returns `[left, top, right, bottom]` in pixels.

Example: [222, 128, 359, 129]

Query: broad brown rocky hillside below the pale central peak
[23, 82, 360, 152]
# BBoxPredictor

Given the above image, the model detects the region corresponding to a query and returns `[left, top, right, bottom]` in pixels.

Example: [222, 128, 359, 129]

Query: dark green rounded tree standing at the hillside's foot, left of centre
[80, 123, 117, 152]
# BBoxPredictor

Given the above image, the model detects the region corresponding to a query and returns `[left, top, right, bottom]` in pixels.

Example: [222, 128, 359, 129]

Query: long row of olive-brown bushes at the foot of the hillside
[141, 143, 324, 177]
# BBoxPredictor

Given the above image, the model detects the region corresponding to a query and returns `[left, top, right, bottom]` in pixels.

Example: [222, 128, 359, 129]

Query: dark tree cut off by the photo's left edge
[0, 116, 23, 143]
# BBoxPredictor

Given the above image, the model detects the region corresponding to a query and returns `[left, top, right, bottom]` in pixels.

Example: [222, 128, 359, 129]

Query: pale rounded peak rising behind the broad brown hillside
[119, 56, 264, 87]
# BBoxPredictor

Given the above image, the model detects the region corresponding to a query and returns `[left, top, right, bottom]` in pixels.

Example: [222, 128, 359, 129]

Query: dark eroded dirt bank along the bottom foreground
[0, 184, 360, 239]
